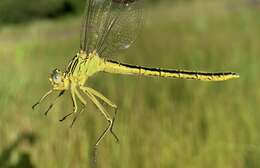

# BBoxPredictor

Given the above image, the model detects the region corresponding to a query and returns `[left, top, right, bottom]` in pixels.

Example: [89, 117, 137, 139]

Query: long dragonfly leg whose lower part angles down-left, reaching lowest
[80, 90, 119, 146]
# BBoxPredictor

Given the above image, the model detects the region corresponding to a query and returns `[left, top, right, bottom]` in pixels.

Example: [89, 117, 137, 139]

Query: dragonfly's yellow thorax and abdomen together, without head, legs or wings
[68, 52, 239, 85]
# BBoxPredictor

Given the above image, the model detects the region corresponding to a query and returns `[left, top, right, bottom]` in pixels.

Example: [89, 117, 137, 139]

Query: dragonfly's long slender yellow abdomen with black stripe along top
[104, 61, 239, 81]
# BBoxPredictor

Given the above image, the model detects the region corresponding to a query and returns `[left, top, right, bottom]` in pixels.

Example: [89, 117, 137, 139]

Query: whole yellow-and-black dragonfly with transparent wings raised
[32, 0, 239, 146]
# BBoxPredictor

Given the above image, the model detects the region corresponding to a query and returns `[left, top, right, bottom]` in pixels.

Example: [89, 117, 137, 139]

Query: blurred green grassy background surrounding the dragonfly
[0, 0, 260, 168]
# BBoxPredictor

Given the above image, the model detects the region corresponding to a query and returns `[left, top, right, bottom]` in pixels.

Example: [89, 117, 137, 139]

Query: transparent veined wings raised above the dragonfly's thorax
[80, 0, 142, 57]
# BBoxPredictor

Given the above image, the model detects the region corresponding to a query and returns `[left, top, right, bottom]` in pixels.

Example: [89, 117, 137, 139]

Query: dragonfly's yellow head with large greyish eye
[49, 69, 69, 90]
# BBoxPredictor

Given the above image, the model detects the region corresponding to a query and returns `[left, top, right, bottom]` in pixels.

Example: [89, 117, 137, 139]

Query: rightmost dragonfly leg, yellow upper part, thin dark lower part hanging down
[80, 86, 119, 142]
